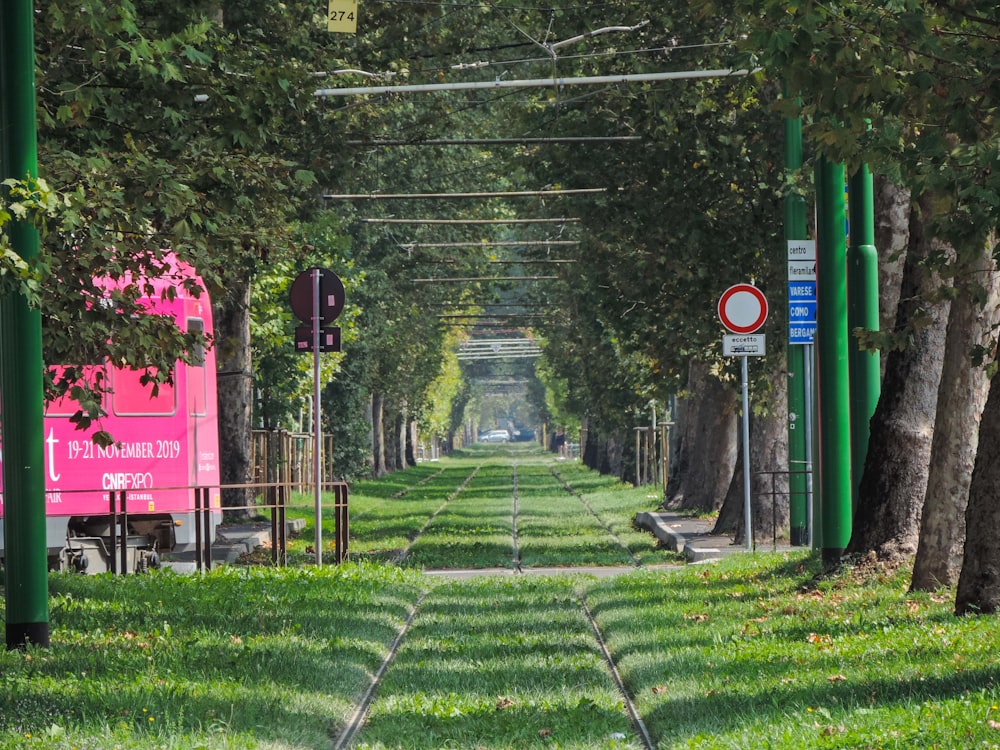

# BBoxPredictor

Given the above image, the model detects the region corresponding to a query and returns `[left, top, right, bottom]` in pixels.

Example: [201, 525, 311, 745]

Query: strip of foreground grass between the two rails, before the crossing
[357, 578, 641, 750]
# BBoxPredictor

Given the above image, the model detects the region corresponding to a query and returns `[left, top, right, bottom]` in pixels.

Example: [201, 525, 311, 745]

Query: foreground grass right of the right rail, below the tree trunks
[588, 555, 1000, 749]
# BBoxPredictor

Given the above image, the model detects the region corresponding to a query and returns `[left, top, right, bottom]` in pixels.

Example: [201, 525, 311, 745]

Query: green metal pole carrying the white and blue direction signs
[784, 111, 812, 546]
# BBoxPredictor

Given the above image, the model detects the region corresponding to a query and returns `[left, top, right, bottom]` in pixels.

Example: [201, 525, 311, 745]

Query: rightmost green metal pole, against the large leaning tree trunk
[847, 164, 881, 508]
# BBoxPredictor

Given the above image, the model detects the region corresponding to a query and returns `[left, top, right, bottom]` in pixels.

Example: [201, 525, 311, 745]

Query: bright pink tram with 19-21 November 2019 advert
[0, 256, 222, 573]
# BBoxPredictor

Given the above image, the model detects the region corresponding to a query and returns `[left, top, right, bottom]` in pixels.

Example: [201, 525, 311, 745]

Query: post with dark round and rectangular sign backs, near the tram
[291, 268, 344, 567]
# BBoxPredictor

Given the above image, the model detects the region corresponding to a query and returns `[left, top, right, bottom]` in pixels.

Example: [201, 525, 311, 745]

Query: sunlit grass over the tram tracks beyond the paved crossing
[288, 452, 680, 568]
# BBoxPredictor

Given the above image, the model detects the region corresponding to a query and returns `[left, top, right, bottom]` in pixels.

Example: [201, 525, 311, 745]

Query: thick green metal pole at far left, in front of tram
[0, 0, 49, 649]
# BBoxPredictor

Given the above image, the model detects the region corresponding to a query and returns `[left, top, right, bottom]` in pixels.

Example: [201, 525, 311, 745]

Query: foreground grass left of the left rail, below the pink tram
[0, 565, 421, 750]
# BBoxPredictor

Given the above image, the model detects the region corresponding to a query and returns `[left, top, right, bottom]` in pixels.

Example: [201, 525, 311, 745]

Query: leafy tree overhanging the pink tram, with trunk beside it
[36, 2, 332, 505]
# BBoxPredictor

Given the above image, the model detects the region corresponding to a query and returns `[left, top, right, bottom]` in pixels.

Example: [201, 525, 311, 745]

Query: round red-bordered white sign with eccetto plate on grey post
[719, 284, 767, 552]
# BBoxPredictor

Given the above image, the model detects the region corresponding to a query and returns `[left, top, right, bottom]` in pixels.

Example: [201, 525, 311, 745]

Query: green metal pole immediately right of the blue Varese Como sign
[816, 158, 851, 566]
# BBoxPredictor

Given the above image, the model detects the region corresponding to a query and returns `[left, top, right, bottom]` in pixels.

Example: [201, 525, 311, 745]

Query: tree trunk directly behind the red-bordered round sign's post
[712, 368, 790, 544]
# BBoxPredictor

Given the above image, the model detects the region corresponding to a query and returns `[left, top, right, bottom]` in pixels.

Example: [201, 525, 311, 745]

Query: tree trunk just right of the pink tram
[214, 278, 253, 513]
